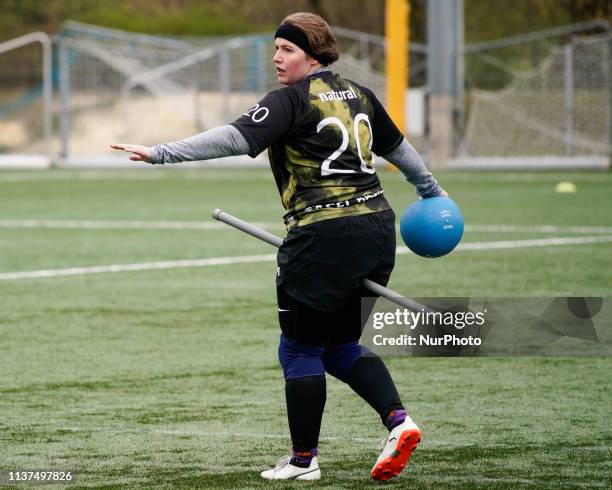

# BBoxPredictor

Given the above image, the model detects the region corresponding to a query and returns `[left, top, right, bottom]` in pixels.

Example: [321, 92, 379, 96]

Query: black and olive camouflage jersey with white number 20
[232, 70, 403, 229]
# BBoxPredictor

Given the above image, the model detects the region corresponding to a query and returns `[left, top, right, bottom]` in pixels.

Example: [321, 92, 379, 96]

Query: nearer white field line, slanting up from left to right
[0, 235, 612, 281]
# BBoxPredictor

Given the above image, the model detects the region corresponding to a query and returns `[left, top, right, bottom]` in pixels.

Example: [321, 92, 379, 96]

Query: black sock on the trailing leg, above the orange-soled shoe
[342, 354, 404, 424]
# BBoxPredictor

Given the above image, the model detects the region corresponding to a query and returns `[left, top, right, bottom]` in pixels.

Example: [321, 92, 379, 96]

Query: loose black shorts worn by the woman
[276, 209, 395, 346]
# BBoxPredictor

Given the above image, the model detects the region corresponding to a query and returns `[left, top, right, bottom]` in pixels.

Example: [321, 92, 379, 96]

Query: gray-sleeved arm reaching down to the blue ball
[382, 138, 447, 198]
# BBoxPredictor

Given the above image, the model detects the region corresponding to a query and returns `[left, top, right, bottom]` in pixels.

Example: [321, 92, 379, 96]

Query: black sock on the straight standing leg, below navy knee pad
[285, 376, 326, 452]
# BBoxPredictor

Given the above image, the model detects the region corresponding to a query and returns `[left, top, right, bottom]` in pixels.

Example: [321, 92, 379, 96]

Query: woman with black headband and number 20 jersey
[112, 13, 446, 480]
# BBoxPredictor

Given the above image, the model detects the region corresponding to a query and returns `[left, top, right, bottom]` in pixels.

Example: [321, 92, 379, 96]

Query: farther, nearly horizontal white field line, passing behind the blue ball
[0, 219, 612, 234]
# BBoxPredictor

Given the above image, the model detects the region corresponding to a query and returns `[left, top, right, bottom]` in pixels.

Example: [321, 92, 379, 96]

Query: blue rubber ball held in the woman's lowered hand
[400, 197, 463, 257]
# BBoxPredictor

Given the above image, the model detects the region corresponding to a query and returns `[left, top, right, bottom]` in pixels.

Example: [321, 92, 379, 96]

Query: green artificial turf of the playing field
[0, 168, 612, 488]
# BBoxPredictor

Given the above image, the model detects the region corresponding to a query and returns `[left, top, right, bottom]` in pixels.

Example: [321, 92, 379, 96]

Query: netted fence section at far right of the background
[459, 34, 612, 166]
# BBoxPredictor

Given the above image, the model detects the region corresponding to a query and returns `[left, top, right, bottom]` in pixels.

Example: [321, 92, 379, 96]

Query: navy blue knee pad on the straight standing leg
[278, 334, 325, 381]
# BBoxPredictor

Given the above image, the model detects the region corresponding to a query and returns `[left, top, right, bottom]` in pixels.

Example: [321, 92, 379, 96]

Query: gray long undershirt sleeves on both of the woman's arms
[151, 125, 442, 197]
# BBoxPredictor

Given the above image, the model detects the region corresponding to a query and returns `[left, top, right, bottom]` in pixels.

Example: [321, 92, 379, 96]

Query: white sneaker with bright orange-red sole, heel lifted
[370, 416, 421, 480]
